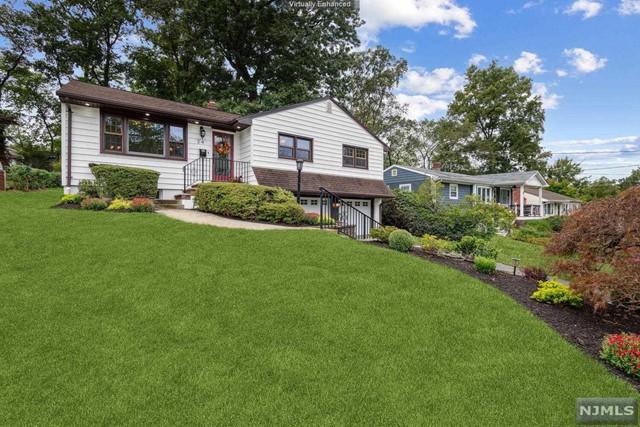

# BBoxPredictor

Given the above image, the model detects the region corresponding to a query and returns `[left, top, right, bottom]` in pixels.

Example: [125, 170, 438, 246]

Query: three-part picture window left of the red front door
[102, 113, 186, 160]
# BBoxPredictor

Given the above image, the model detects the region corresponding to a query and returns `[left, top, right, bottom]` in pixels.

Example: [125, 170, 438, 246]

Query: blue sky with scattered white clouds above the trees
[360, 0, 640, 178]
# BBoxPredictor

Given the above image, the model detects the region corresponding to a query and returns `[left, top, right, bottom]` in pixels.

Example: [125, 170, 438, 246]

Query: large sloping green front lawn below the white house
[0, 191, 637, 426]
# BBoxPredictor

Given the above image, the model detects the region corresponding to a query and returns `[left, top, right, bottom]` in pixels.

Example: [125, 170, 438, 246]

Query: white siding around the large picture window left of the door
[61, 104, 237, 198]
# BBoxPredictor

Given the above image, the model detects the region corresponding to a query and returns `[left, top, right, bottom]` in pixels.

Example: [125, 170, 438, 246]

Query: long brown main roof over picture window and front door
[56, 80, 246, 128]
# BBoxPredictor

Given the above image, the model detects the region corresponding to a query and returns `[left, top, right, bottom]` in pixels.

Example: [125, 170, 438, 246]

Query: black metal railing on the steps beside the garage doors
[320, 187, 382, 240]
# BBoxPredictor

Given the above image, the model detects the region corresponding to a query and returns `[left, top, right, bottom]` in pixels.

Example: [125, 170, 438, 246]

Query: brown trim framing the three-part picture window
[100, 109, 189, 162]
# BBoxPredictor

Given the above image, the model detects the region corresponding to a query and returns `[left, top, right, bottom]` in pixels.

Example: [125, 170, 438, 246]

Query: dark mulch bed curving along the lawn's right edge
[371, 242, 640, 390]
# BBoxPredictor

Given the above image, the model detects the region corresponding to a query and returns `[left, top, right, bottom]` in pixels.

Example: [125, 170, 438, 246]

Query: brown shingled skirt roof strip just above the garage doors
[253, 167, 393, 198]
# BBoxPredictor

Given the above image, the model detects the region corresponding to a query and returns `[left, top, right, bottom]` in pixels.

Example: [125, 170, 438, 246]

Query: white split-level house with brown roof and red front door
[57, 81, 393, 220]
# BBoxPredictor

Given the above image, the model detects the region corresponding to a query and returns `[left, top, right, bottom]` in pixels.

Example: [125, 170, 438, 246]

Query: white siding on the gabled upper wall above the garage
[252, 101, 384, 180]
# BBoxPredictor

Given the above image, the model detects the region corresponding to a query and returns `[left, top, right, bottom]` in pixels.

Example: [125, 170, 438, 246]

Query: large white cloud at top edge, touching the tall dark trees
[358, 0, 477, 44]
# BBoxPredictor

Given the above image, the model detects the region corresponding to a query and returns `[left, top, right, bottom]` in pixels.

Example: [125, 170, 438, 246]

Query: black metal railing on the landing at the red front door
[182, 157, 250, 190]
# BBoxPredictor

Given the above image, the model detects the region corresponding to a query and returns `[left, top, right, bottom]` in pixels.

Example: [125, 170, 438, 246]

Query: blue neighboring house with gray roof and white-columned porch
[384, 163, 564, 220]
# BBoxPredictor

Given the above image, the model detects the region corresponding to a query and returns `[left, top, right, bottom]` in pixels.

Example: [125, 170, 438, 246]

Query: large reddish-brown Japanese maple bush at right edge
[545, 186, 640, 311]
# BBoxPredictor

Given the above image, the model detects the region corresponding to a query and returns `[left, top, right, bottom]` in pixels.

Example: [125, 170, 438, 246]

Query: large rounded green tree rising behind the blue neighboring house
[447, 61, 549, 173]
